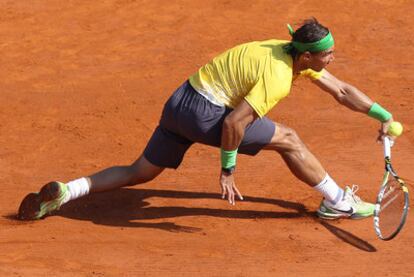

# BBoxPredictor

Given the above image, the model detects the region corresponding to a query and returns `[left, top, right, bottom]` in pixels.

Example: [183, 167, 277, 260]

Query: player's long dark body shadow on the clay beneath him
[54, 188, 309, 232]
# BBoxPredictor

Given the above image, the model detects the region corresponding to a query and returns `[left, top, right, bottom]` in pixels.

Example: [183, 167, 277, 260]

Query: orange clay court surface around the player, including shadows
[0, 0, 414, 276]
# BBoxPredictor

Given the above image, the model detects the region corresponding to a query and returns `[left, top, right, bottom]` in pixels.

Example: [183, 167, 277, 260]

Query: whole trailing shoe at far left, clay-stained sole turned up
[18, 182, 69, 220]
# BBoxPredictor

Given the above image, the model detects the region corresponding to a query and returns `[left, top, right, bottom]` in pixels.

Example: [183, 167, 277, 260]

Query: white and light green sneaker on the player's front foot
[317, 185, 375, 219]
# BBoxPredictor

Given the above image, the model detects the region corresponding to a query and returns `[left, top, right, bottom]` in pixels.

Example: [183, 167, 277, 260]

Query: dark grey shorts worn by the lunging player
[144, 78, 275, 168]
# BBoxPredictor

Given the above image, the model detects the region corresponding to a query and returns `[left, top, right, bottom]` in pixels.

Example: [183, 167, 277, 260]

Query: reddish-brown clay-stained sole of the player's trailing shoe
[17, 182, 61, 220]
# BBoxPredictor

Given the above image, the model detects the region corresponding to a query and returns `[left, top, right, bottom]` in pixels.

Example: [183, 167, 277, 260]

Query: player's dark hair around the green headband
[288, 17, 329, 58]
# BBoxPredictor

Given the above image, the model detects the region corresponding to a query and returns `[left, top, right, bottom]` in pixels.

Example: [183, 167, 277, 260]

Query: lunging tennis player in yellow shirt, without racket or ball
[18, 18, 393, 220]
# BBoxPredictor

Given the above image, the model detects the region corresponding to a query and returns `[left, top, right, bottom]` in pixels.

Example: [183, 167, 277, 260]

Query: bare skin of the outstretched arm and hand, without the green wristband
[313, 70, 393, 140]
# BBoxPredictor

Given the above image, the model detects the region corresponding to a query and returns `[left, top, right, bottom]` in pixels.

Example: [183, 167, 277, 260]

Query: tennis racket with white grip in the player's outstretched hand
[374, 136, 409, 240]
